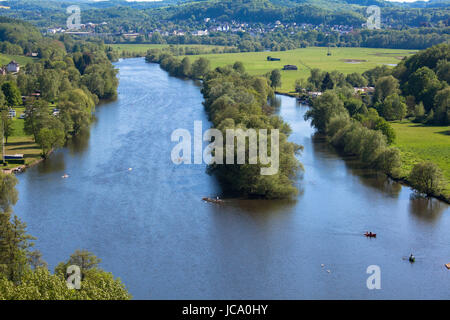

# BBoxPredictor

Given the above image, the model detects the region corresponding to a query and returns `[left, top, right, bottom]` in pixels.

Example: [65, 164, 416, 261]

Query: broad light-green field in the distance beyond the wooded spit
[191, 47, 415, 92]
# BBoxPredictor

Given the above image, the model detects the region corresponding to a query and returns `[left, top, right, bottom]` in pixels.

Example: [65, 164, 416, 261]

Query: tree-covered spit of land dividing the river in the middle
[146, 49, 303, 199]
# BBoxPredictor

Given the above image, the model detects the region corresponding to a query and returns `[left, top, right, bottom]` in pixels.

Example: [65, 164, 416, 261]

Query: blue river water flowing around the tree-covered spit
[15, 59, 450, 299]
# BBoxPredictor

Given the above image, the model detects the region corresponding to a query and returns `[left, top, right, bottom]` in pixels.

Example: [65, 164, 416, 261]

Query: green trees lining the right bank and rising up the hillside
[297, 44, 450, 196]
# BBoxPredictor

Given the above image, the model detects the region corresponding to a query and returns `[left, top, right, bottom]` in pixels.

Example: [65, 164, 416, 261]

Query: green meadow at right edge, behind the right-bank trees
[391, 121, 450, 197]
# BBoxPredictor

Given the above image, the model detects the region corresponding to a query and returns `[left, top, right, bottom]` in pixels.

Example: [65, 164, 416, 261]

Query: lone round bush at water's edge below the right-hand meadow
[409, 162, 443, 196]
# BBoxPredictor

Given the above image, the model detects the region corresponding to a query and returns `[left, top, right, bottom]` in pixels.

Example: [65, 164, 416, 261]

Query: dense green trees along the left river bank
[0, 22, 118, 157]
